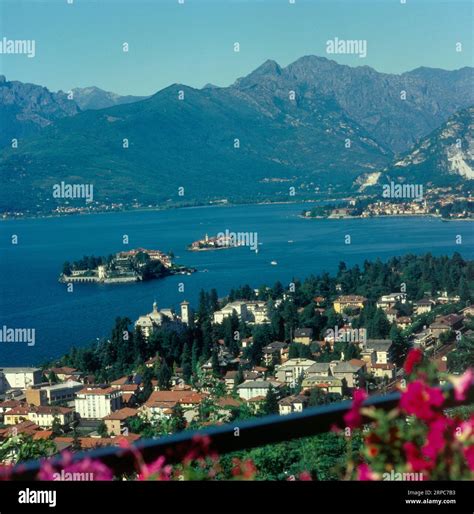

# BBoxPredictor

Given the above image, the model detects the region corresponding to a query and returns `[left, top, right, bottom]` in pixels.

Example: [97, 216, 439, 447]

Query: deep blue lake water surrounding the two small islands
[0, 200, 474, 367]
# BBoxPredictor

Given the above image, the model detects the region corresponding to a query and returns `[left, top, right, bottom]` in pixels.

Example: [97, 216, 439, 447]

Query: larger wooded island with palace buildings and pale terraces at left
[59, 248, 196, 284]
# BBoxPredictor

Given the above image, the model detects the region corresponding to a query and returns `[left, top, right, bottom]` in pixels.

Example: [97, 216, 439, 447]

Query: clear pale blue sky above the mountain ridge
[0, 0, 473, 95]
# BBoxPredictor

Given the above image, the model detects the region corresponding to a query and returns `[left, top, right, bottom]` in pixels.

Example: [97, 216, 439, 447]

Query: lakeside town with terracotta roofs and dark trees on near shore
[0, 250, 474, 472]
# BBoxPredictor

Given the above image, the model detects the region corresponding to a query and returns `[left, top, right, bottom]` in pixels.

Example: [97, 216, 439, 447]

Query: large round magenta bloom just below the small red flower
[400, 380, 444, 421]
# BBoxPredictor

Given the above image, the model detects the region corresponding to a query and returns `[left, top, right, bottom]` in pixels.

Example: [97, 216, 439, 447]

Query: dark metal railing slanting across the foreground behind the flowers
[11, 386, 474, 480]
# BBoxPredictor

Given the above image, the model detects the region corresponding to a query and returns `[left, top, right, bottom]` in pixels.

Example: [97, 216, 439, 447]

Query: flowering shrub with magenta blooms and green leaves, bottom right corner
[344, 350, 474, 480]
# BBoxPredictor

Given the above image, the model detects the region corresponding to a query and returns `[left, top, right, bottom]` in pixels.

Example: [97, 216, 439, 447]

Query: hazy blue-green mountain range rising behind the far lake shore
[0, 56, 474, 211]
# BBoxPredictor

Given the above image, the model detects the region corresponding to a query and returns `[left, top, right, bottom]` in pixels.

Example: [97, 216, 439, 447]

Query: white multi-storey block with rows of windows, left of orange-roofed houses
[74, 387, 122, 419]
